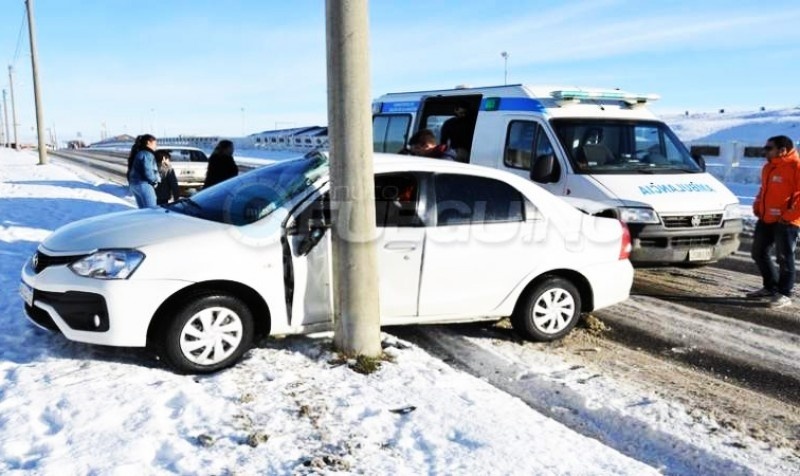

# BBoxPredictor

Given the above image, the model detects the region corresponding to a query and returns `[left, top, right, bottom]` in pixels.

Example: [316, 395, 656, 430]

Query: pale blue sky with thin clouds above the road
[0, 0, 800, 141]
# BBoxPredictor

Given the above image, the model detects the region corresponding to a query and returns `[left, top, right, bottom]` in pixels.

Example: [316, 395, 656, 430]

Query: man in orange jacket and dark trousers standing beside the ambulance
[747, 136, 800, 307]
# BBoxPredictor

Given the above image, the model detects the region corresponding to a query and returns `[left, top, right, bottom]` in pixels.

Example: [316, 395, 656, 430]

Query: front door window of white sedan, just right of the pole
[375, 174, 422, 228]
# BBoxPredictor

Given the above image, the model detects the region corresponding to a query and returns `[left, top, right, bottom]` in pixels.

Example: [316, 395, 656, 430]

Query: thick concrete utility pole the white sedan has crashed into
[325, 0, 381, 357]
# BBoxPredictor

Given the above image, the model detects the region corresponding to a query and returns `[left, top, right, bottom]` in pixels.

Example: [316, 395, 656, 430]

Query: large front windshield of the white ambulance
[552, 119, 702, 174]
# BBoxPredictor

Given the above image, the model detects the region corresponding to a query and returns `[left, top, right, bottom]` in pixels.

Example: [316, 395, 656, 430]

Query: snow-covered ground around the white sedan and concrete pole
[0, 106, 796, 475]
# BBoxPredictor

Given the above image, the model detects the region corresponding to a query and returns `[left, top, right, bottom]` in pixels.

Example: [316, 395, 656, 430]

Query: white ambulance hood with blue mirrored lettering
[594, 173, 738, 213]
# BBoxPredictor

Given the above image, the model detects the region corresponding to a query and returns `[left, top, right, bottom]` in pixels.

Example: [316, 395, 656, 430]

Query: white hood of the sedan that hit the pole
[42, 208, 229, 254]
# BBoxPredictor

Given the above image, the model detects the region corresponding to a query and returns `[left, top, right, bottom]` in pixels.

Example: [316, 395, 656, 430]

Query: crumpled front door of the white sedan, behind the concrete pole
[284, 173, 425, 325]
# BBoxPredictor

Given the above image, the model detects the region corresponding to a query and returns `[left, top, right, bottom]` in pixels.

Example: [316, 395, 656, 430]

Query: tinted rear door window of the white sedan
[435, 174, 527, 226]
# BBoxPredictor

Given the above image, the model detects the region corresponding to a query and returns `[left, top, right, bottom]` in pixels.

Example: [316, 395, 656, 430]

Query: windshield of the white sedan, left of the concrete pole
[166, 152, 328, 226]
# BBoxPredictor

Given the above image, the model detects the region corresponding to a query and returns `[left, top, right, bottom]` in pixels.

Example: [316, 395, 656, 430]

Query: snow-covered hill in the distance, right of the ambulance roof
[662, 107, 800, 145]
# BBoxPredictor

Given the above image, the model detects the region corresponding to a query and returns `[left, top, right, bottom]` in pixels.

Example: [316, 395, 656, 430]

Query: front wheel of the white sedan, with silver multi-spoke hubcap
[161, 294, 253, 373]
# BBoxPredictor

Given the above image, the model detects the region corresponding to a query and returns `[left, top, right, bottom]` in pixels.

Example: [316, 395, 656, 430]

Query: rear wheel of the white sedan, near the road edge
[511, 277, 581, 341]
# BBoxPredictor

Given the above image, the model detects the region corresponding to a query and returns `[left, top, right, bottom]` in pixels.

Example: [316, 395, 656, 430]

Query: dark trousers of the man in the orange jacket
[750, 220, 800, 296]
